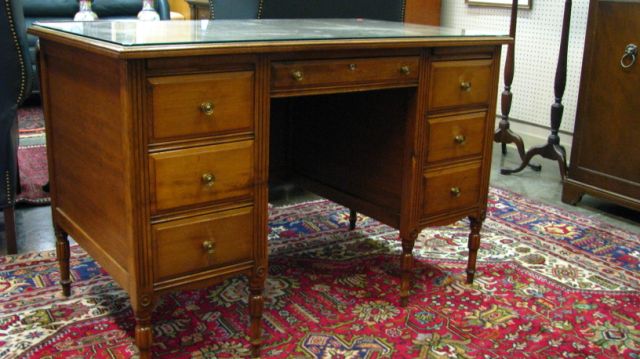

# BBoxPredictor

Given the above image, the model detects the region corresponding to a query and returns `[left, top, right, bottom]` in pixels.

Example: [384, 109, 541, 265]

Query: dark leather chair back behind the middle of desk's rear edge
[209, 0, 406, 21]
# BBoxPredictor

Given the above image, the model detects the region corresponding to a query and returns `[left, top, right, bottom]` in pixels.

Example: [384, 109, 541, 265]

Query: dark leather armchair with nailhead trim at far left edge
[0, 0, 34, 254]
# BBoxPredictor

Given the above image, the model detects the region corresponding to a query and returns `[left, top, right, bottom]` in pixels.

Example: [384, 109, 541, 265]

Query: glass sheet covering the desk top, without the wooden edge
[36, 19, 508, 47]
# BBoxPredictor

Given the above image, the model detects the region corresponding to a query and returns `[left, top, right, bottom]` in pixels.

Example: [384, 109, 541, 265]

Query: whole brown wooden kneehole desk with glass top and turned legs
[30, 20, 510, 356]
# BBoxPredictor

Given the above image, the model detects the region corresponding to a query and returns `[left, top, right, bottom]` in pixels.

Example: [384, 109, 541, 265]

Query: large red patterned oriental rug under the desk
[0, 189, 640, 358]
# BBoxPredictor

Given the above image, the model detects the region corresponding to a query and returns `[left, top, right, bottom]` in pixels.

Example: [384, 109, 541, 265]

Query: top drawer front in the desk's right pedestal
[429, 60, 493, 110]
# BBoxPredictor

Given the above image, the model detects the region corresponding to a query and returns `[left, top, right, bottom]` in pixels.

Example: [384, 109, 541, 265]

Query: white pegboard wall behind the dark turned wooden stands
[441, 0, 589, 133]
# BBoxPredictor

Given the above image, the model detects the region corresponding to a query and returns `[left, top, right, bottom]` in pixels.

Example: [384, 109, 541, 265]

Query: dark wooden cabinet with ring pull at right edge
[562, 0, 640, 210]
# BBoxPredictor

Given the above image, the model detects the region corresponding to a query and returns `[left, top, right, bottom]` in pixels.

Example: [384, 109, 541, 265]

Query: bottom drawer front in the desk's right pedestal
[422, 162, 481, 216]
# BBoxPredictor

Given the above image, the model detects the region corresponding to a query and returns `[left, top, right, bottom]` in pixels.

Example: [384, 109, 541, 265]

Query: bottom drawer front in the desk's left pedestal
[153, 207, 253, 281]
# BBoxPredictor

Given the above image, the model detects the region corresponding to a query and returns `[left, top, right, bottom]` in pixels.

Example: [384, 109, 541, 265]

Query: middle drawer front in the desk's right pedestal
[427, 112, 487, 163]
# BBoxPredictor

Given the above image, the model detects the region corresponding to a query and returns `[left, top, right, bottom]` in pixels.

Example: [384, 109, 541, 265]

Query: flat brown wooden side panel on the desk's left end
[42, 42, 132, 288]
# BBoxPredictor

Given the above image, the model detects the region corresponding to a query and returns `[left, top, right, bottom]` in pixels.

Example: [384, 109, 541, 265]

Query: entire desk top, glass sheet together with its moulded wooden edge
[29, 19, 510, 58]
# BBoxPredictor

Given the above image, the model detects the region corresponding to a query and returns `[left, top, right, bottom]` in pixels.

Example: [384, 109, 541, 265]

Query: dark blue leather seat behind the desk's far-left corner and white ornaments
[22, 0, 170, 93]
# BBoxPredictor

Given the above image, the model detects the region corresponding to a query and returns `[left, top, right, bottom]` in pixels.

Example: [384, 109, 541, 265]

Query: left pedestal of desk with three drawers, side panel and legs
[41, 39, 268, 357]
